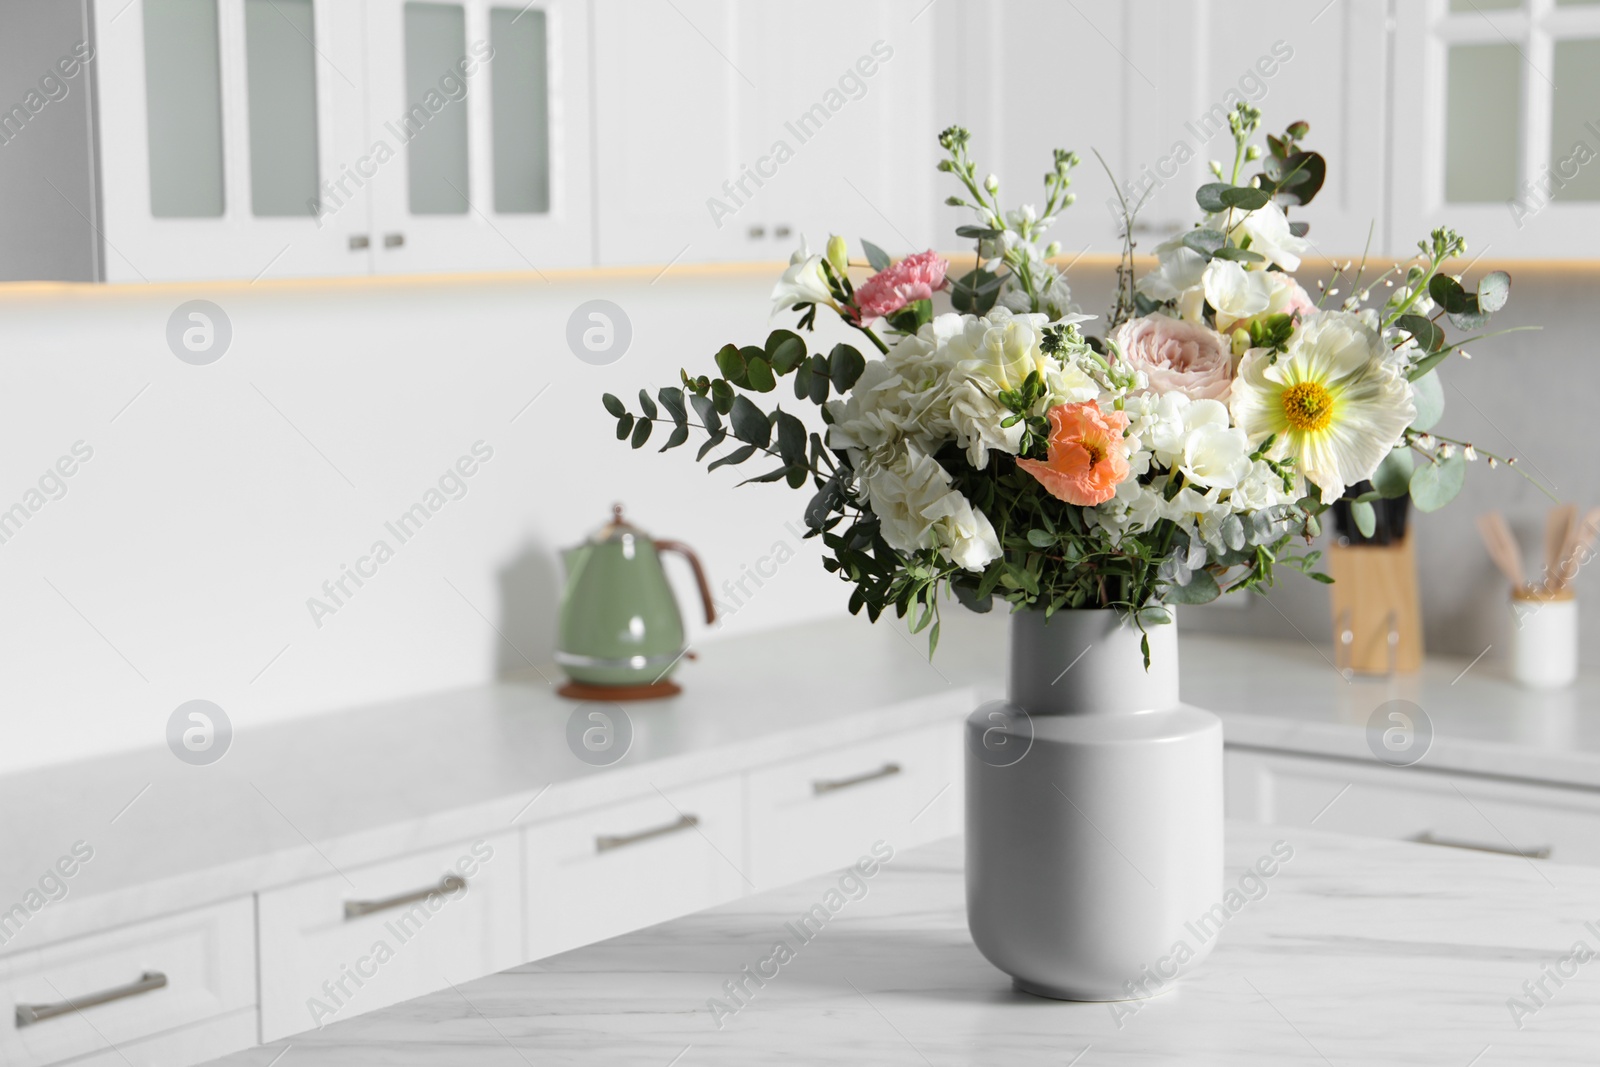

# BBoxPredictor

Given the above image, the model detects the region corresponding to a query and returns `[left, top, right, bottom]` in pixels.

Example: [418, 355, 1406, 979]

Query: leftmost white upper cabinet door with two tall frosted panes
[94, 0, 368, 282]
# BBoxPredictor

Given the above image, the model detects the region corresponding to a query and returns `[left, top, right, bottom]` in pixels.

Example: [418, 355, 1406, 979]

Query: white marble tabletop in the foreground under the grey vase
[206, 824, 1600, 1067]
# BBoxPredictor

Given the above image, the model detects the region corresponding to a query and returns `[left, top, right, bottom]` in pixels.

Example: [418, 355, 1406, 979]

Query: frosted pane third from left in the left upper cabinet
[403, 3, 467, 214]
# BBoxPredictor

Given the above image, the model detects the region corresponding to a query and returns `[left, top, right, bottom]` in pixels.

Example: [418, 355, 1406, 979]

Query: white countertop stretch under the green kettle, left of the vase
[0, 616, 1002, 955]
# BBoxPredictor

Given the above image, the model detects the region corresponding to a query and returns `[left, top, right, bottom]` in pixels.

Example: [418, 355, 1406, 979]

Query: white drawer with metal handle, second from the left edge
[259, 832, 522, 1041]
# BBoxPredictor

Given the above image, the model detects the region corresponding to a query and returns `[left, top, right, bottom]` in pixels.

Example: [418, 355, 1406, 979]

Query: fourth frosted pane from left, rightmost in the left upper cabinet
[490, 8, 550, 214]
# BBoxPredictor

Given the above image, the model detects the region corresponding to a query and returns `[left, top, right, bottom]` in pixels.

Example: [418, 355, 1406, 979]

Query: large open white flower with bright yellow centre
[1232, 312, 1416, 504]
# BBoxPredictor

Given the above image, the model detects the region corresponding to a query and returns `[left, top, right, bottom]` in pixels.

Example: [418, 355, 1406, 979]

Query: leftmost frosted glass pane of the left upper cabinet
[144, 0, 222, 219]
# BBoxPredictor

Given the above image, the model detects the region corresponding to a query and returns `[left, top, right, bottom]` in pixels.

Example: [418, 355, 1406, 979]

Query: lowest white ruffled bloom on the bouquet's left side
[864, 445, 1000, 571]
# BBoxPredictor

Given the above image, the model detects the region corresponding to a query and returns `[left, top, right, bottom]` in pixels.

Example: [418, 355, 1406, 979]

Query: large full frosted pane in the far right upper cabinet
[1445, 45, 1522, 203]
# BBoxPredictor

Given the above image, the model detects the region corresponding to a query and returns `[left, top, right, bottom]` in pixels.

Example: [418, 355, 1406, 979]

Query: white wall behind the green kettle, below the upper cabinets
[0, 269, 845, 773]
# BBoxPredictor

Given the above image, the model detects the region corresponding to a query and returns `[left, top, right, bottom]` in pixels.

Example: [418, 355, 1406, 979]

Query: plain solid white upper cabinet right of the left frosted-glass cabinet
[595, 0, 938, 266]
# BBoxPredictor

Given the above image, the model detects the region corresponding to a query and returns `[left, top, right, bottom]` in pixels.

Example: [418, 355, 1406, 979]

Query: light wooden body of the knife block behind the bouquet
[1328, 537, 1422, 675]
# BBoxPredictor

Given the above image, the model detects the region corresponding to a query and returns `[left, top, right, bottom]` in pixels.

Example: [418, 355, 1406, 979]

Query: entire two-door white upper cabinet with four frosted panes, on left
[94, 0, 592, 282]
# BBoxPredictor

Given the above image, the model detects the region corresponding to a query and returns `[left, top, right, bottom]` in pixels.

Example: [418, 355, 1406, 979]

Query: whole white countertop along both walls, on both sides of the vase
[0, 609, 1600, 953]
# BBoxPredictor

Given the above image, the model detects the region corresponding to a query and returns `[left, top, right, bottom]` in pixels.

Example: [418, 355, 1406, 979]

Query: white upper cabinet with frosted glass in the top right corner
[1392, 0, 1600, 259]
